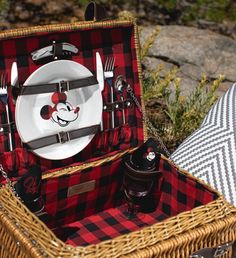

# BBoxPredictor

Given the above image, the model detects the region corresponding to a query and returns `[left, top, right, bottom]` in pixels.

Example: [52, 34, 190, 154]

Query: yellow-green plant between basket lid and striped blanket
[141, 27, 224, 151]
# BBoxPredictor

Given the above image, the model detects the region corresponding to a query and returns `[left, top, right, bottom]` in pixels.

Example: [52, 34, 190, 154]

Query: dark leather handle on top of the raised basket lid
[84, 2, 107, 21]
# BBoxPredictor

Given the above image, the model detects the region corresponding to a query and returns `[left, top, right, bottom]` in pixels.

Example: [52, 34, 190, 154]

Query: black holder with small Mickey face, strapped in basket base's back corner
[123, 138, 162, 218]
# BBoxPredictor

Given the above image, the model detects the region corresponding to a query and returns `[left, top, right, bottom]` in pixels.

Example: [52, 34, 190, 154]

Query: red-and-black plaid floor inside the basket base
[63, 205, 167, 246]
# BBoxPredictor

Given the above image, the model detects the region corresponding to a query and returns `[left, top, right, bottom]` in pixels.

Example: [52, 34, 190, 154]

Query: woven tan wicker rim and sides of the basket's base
[0, 176, 236, 258]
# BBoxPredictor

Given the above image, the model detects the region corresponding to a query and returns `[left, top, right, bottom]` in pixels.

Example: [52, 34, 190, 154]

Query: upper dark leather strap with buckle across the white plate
[19, 76, 98, 95]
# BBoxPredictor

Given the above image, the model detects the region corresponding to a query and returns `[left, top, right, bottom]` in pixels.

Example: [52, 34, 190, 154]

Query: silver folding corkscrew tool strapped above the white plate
[31, 42, 79, 61]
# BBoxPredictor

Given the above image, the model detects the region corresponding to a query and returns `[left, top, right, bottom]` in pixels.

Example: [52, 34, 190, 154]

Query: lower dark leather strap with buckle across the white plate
[24, 125, 100, 150]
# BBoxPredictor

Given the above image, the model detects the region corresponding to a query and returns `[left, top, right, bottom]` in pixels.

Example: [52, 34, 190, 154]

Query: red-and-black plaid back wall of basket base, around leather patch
[42, 154, 123, 228]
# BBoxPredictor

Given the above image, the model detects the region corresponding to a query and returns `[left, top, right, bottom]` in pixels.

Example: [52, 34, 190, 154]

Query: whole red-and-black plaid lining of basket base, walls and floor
[44, 159, 217, 246]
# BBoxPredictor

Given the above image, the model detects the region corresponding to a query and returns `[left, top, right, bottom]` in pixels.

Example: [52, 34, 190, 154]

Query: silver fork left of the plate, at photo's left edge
[0, 73, 13, 151]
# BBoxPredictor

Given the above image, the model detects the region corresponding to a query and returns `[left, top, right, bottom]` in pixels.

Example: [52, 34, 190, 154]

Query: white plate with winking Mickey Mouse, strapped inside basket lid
[16, 60, 102, 160]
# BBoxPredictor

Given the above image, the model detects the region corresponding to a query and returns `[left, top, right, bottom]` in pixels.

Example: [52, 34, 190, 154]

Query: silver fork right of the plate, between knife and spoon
[104, 57, 115, 128]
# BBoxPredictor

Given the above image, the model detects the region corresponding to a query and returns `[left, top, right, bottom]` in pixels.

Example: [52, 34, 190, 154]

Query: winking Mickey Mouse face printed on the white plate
[40, 92, 80, 127]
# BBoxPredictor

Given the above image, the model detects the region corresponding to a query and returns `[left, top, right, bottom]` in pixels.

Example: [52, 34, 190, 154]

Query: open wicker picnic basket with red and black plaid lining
[0, 7, 236, 258]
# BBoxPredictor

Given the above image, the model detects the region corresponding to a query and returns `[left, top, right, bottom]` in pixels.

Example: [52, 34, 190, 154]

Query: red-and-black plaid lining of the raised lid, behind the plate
[0, 25, 143, 181]
